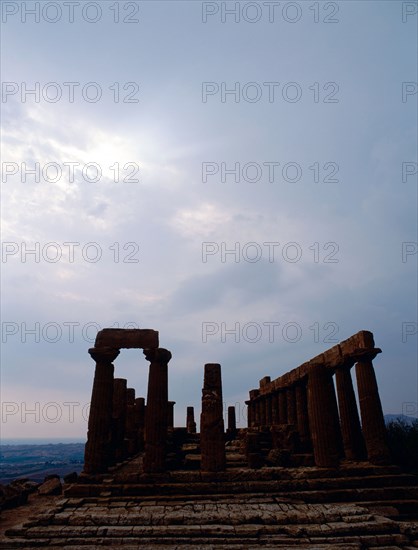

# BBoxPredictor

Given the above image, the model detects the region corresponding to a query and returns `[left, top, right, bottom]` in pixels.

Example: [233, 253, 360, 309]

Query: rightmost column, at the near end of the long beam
[356, 360, 390, 464]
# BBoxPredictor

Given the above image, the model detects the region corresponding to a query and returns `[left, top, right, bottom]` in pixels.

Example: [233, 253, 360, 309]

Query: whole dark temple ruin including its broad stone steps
[0, 329, 418, 550]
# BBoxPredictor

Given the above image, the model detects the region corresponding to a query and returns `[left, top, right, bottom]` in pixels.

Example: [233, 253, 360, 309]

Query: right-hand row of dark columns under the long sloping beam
[247, 356, 389, 467]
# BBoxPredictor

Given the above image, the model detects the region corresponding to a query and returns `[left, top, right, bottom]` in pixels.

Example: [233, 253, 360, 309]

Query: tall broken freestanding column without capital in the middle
[200, 363, 226, 472]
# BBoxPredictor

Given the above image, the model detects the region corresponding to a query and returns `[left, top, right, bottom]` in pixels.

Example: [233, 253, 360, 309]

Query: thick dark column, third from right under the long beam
[308, 365, 339, 468]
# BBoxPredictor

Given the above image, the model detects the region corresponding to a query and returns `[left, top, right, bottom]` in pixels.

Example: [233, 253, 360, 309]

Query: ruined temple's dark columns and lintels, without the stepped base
[84, 329, 390, 475]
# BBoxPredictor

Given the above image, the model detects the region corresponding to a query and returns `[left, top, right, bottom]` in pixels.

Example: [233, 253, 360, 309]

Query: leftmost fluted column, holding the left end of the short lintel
[84, 347, 119, 474]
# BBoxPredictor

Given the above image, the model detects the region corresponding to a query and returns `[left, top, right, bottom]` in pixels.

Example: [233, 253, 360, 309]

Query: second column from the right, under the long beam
[335, 366, 366, 460]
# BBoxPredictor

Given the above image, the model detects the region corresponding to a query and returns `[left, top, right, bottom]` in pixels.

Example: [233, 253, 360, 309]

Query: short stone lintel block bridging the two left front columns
[94, 328, 159, 349]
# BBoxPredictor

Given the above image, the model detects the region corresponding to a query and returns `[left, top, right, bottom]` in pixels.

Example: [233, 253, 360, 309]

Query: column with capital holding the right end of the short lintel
[144, 348, 171, 472]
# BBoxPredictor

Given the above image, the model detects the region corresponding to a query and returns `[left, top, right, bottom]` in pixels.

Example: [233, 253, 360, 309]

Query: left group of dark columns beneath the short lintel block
[84, 347, 174, 474]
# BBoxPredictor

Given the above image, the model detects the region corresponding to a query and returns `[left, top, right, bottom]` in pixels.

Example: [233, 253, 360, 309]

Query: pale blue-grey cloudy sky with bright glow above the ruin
[0, 0, 418, 438]
